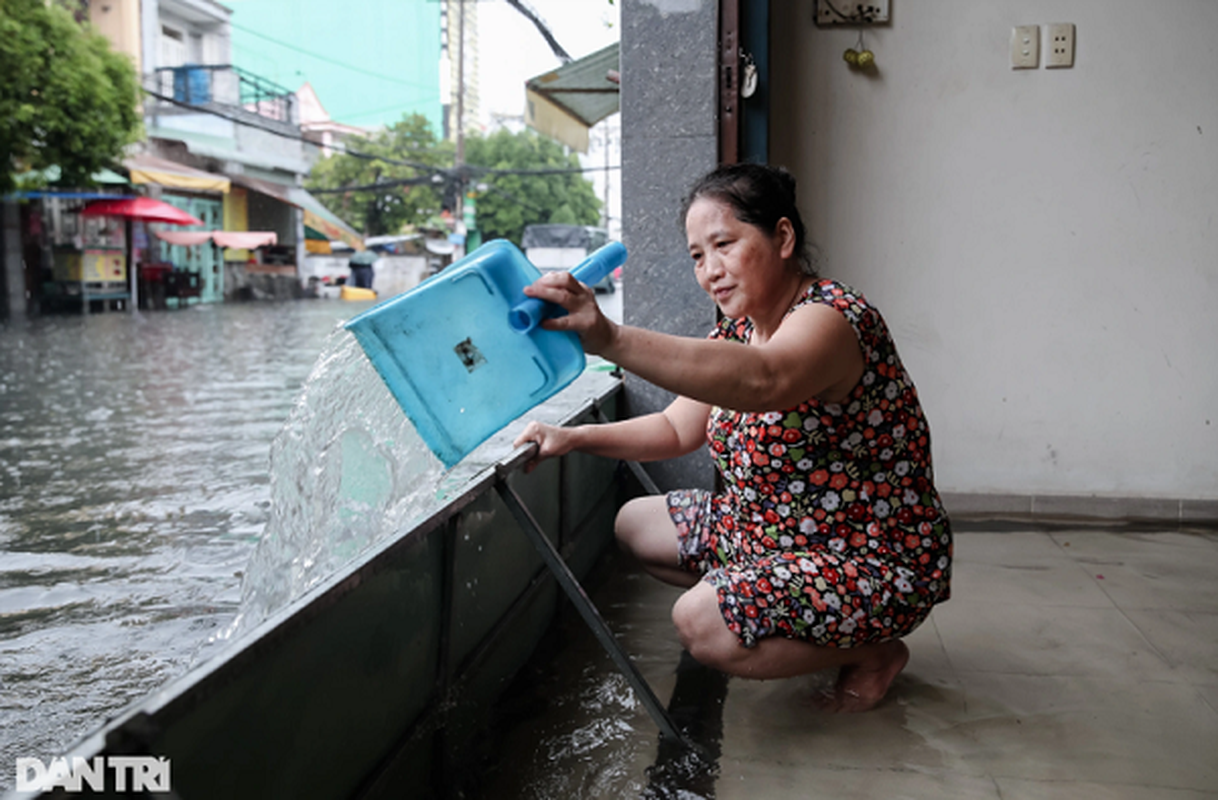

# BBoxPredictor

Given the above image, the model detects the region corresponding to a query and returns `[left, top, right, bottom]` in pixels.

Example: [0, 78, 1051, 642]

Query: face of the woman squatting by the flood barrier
[686, 197, 795, 319]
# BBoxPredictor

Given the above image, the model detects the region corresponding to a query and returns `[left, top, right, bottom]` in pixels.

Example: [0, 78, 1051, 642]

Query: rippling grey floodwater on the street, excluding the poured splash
[0, 301, 368, 788]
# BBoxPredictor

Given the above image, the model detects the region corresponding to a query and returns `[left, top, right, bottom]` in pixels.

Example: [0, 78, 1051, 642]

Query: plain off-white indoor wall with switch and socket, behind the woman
[770, 0, 1218, 499]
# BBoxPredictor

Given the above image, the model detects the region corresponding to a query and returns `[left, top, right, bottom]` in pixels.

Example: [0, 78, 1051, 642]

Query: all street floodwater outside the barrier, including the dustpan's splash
[0, 283, 628, 790]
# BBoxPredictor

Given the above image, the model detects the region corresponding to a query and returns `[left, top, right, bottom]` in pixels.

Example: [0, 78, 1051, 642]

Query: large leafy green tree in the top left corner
[0, 0, 140, 194]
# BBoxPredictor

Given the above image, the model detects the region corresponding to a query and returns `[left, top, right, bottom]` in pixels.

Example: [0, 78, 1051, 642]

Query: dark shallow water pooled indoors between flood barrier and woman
[454, 549, 727, 800]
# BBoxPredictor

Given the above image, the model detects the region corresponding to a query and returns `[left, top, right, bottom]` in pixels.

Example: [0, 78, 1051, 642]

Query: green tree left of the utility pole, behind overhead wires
[306, 114, 452, 236]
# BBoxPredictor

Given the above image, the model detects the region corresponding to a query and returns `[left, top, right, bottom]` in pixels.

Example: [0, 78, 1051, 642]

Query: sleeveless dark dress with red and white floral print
[667, 280, 951, 648]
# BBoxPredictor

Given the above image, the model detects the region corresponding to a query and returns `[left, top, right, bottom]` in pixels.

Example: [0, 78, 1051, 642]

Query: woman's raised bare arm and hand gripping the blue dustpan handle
[526, 273, 864, 412]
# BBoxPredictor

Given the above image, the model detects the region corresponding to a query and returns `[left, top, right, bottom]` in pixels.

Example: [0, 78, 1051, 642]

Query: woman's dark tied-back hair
[681, 164, 816, 278]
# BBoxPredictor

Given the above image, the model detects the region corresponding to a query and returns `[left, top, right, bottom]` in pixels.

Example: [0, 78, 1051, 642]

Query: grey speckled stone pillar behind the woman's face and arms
[621, 0, 719, 489]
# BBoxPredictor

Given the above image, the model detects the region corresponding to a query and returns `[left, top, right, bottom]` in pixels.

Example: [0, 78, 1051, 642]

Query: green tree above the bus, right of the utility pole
[465, 129, 600, 245]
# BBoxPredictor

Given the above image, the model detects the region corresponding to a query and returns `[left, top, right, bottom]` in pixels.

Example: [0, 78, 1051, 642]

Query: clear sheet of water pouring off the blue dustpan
[225, 329, 443, 638]
